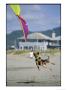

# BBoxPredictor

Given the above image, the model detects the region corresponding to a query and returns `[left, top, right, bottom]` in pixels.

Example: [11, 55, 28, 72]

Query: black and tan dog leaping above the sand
[33, 52, 49, 69]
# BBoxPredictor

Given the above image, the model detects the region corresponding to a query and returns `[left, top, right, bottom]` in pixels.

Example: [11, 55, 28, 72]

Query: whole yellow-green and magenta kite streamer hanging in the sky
[10, 5, 29, 41]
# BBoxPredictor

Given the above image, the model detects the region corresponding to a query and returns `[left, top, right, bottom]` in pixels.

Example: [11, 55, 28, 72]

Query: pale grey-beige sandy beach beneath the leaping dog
[6, 54, 61, 86]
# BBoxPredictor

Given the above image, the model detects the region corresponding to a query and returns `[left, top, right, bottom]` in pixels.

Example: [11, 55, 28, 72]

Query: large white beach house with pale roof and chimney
[17, 33, 60, 51]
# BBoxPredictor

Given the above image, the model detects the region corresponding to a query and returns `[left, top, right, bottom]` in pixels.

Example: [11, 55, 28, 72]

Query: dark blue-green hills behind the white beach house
[6, 27, 61, 49]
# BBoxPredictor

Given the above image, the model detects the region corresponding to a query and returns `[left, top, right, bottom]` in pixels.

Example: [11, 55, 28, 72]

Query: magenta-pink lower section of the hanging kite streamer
[18, 16, 29, 40]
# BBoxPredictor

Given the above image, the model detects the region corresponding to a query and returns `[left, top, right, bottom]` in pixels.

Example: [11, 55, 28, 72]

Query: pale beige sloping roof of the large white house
[18, 33, 52, 40]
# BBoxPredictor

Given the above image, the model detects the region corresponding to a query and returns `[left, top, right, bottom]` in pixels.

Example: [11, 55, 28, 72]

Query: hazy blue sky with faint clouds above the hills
[6, 4, 61, 33]
